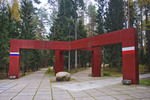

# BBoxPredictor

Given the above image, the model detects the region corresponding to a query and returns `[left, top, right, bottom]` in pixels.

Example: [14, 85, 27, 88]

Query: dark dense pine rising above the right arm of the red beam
[105, 0, 124, 32]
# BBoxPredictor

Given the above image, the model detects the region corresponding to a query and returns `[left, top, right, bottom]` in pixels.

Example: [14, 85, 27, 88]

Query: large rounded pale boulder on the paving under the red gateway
[56, 72, 71, 81]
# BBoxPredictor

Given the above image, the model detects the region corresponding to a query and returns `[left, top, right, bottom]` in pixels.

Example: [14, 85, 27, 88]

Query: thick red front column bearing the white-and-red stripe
[122, 32, 139, 84]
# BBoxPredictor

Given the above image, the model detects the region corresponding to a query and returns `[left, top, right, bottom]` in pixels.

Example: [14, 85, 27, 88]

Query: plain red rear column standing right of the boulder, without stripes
[92, 47, 101, 77]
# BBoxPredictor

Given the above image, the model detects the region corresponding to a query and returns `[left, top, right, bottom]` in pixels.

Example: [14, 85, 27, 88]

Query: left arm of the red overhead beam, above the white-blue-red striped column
[10, 39, 69, 52]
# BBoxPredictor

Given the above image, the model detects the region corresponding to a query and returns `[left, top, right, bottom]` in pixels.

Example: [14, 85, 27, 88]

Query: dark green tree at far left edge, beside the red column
[0, 4, 9, 76]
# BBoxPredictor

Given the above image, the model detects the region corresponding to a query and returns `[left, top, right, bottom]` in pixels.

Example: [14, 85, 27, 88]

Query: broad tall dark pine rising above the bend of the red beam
[51, 0, 83, 41]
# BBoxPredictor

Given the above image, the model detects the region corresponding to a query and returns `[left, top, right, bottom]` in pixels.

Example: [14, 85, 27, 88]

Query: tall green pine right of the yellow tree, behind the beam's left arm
[20, 0, 38, 75]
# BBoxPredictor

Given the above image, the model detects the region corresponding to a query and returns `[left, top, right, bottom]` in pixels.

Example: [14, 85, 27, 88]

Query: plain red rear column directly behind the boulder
[55, 50, 64, 74]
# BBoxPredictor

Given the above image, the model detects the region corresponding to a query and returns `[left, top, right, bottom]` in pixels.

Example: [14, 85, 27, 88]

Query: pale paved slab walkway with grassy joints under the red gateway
[0, 68, 150, 100]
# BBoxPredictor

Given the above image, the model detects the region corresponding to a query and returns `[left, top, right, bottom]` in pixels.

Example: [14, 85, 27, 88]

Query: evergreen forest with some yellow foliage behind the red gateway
[0, 0, 150, 79]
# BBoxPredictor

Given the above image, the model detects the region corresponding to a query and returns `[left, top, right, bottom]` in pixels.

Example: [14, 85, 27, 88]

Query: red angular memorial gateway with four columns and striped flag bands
[9, 28, 139, 84]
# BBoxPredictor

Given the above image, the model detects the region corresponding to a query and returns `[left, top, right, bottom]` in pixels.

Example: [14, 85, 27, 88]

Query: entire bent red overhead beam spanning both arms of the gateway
[10, 28, 135, 52]
